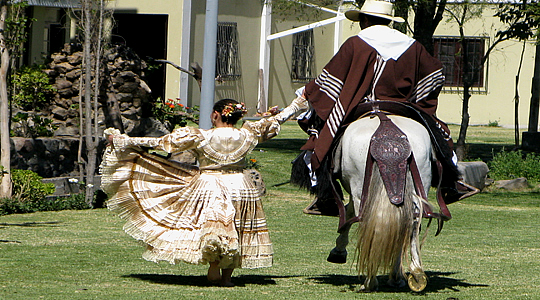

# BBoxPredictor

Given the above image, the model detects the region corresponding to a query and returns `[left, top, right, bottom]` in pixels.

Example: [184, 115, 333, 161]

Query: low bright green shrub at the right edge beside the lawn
[489, 149, 540, 181]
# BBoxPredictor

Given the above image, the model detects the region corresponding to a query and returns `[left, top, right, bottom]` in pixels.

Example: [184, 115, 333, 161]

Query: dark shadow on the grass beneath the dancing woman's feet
[122, 274, 301, 286]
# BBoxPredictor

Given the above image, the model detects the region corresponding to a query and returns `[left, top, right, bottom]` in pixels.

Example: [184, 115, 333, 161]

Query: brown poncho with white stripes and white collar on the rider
[300, 26, 444, 169]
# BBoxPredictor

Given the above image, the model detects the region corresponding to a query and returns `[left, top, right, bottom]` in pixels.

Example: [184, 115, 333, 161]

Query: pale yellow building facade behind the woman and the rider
[22, 0, 535, 127]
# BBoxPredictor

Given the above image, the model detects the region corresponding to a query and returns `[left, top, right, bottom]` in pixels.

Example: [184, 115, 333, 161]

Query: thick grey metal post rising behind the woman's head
[199, 0, 219, 129]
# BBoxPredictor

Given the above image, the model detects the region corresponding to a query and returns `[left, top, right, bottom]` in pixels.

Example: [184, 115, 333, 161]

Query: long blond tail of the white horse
[356, 164, 422, 277]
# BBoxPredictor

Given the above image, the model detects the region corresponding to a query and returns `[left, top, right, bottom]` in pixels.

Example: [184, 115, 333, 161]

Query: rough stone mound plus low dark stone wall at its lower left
[11, 44, 168, 178]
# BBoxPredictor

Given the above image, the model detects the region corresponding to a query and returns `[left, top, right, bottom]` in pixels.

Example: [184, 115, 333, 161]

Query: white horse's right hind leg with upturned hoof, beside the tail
[408, 193, 427, 292]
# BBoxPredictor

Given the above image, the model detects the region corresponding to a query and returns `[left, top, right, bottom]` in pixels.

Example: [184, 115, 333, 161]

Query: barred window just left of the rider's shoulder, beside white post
[291, 29, 315, 82]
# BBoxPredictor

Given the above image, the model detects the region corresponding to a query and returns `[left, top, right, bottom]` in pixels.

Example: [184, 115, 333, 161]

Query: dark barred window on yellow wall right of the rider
[433, 37, 486, 91]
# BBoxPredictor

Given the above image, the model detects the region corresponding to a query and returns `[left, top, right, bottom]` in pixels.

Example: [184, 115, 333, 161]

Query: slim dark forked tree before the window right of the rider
[447, 0, 533, 160]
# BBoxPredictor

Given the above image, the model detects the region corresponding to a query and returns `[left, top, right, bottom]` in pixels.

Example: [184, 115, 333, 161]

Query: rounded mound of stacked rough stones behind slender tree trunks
[44, 44, 167, 136]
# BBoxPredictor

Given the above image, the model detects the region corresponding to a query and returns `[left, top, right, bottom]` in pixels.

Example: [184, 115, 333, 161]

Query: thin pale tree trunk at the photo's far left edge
[0, 0, 12, 198]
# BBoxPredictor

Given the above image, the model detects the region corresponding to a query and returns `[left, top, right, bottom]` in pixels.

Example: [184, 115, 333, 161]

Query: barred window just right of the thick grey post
[216, 22, 241, 80]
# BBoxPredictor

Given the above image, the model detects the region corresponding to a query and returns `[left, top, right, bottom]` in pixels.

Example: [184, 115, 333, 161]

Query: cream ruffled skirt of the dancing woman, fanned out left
[100, 146, 273, 268]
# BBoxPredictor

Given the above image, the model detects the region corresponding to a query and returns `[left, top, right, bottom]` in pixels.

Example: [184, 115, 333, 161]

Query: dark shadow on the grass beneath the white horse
[308, 272, 489, 293]
